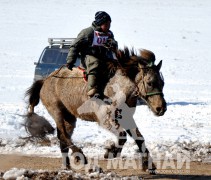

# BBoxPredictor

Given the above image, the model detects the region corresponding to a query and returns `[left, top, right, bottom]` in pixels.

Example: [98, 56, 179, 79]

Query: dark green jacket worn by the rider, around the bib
[67, 22, 118, 65]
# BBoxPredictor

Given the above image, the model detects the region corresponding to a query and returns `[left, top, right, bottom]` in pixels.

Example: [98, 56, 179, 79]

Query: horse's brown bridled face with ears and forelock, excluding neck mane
[135, 50, 167, 116]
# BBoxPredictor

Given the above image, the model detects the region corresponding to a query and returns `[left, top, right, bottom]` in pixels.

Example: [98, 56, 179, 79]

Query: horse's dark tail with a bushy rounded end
[24, 80, 54, 138]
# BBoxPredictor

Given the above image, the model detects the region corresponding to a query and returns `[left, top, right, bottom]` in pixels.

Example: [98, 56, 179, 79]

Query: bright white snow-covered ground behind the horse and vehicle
[0, 0, 211, 162]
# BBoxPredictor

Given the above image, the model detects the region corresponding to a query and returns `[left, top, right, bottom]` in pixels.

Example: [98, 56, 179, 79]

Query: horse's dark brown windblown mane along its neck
[108, 47, 155, 79]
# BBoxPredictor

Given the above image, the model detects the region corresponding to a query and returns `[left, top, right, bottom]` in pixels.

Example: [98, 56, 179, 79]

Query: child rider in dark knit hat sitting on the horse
[67, 11, 118, 97]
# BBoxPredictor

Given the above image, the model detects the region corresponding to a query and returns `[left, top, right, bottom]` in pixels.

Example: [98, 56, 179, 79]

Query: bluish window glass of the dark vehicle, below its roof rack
[41, 49, 60, 64]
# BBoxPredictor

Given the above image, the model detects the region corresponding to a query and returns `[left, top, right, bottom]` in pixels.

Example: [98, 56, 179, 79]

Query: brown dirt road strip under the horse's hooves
[0, 155, 211, 179]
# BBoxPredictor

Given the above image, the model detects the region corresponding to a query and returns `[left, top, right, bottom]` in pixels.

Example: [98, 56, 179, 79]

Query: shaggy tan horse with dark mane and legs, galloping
[25, 47, 167, 173]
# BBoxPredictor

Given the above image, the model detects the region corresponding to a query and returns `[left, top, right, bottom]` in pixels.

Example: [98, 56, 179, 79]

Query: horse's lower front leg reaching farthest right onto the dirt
[127, 126, 156, 174]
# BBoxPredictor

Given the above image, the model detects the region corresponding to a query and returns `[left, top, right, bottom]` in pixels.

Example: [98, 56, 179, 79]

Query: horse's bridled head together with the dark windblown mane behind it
[117, 47, 166, 116]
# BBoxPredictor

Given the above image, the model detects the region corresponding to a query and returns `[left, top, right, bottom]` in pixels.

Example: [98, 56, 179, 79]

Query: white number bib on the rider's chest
[92, 31, 111, 46]
